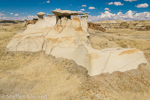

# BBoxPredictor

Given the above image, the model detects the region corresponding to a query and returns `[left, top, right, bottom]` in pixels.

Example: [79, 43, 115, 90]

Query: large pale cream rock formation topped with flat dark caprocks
[7, 10, 147, 76]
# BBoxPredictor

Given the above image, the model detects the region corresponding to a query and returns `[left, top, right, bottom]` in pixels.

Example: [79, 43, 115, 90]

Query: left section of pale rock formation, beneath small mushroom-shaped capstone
[7, 12, 56, 52]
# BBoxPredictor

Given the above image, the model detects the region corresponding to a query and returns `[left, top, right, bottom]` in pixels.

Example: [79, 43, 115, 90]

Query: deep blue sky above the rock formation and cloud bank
[0, 0, 150, 20]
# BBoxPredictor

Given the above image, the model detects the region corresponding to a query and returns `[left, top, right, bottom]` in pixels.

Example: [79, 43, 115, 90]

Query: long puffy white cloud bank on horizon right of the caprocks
[88, 10, 150, 22]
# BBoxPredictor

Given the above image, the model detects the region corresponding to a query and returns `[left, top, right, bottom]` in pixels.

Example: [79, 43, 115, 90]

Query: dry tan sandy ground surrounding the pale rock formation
[0, 21, 150, 100]
